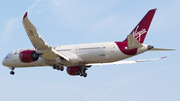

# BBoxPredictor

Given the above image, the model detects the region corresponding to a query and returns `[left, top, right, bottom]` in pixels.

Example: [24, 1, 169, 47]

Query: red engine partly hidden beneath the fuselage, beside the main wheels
[67, 66, 80, 75]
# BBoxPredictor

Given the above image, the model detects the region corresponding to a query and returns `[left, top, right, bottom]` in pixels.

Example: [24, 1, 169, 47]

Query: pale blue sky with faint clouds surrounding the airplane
[0, 0, 180, 101]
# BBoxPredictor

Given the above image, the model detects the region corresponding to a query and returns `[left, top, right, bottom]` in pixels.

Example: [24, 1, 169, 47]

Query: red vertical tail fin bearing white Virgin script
[123, 9, 156, 43]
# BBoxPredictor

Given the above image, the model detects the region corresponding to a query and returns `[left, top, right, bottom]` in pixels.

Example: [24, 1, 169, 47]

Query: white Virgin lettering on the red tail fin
[132, 25, 147, 41]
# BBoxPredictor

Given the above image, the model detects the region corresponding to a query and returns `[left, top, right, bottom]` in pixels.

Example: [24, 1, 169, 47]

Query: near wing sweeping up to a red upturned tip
[23, 12, 69, 61]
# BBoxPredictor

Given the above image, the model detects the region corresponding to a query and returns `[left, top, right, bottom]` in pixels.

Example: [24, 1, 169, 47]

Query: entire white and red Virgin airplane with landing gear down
[2, 9, 173, 77]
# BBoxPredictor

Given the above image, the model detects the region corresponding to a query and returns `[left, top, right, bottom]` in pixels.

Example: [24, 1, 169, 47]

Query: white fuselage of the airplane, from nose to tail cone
[3, 42, 148, 68]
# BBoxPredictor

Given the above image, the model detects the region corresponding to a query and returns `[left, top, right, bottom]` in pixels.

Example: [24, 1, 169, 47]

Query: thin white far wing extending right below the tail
[86, 57, 166, 66]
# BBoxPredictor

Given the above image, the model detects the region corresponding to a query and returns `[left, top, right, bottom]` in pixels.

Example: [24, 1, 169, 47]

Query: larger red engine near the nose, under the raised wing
[19, 50, 39, 63]
